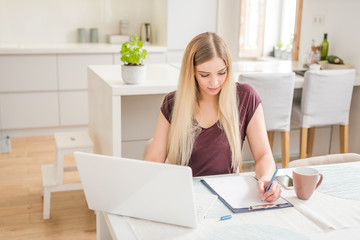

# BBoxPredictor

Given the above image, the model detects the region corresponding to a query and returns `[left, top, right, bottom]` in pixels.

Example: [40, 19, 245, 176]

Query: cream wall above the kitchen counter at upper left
[0, 0, 166, 44]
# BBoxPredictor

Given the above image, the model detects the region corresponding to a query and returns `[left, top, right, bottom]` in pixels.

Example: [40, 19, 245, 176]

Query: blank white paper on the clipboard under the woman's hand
[204, 175, 287, 208]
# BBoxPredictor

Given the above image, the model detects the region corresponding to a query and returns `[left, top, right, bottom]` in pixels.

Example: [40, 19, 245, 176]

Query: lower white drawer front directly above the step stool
[59, 90, 89, 126]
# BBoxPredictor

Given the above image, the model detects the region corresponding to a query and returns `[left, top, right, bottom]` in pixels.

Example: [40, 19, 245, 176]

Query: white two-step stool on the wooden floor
[41, 132, 93, 219]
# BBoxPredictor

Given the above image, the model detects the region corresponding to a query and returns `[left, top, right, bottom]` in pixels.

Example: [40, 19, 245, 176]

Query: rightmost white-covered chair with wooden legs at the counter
[292, 69, 355, 158]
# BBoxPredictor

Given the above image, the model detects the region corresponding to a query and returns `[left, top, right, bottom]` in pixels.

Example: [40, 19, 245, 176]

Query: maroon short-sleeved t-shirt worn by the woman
[161, 83, 261, 177]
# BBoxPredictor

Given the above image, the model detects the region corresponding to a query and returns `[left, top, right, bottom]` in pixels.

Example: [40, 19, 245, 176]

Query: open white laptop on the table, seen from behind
[74, 152, 197, 228]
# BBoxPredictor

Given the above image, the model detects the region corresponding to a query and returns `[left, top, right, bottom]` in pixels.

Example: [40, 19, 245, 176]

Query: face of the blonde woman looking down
[195, 57, 227, 97]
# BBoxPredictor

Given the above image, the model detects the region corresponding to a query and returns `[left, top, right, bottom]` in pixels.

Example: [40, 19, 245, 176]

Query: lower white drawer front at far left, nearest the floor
[0, 92, 59, 129]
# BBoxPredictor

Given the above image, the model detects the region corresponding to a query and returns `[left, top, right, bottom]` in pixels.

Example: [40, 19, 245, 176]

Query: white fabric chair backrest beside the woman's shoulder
[239, 72, 295, 131]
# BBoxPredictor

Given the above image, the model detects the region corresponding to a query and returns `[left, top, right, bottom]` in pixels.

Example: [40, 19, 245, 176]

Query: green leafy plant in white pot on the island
[120, 35, 147, 84]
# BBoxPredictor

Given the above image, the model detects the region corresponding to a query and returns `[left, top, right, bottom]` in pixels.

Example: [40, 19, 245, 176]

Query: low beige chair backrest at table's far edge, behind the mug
[286, 153, 360, 168]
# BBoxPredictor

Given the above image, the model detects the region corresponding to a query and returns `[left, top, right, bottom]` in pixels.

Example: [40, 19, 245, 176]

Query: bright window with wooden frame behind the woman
[238, 0, 302, 60]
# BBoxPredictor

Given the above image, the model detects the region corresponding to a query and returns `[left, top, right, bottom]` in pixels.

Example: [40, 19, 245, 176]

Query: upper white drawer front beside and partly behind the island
[58, 53, 113, 90]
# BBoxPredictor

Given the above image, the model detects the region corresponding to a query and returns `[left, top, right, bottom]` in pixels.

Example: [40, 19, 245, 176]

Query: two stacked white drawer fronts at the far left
[0, 54, 59, 129]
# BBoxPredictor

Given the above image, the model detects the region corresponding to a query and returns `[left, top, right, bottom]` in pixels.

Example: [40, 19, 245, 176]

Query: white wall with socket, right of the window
[299, 0, 360, 71]
